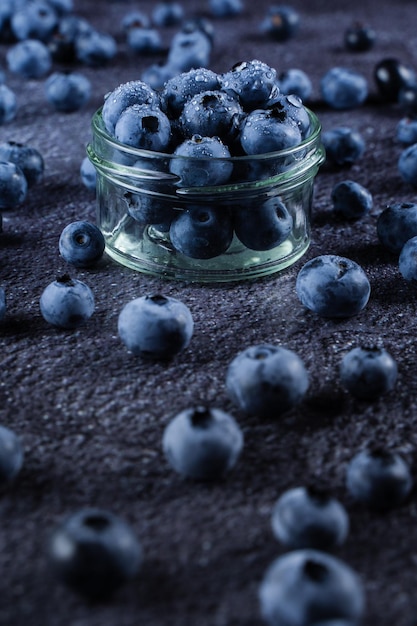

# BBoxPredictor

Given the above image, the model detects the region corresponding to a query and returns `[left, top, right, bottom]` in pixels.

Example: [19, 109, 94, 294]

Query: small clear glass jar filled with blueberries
[87, 110, 324, 282]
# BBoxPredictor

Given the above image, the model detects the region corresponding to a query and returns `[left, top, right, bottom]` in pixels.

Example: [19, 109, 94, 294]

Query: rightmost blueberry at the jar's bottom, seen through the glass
[234, 197, 293, 250]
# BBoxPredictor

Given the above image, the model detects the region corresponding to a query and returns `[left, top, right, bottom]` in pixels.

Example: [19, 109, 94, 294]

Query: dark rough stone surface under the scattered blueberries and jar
[0, 0, 417, 626]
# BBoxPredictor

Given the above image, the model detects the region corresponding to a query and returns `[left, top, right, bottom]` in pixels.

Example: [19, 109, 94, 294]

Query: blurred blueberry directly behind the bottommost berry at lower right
[271, 487, 349, 550]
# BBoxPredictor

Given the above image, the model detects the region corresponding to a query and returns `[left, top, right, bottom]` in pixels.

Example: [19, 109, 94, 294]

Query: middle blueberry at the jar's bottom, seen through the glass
[169, 206, 233, 259]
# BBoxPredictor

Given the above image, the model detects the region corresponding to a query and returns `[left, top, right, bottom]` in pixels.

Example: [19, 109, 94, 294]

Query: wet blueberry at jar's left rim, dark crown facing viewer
[114, 104, 171, 152]
